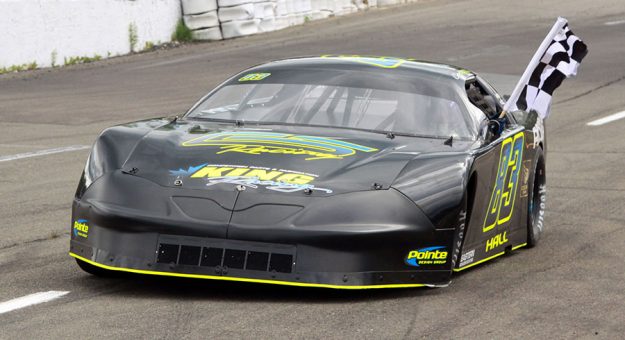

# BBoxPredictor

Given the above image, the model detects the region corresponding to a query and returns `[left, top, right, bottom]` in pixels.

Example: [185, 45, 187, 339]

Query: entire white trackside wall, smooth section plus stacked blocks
[0, 0, 417, 69]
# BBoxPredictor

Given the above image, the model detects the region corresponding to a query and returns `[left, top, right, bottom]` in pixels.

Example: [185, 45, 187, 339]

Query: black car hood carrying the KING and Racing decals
[122, 121, 466, 195]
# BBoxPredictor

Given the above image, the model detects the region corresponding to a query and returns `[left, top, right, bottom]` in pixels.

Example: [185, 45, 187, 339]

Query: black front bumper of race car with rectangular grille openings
[70, 179, 456, 289]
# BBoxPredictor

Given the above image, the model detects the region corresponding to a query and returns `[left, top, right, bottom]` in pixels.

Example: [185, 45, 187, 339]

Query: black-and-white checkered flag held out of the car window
[504, 18, 588, 119]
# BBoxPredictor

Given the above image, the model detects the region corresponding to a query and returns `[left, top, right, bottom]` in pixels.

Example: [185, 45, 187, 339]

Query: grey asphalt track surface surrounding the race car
[0, 0, 625, 339]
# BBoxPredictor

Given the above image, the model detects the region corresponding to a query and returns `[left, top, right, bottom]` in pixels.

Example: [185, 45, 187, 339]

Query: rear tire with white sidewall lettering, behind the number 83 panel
[527, 147, 547, 247]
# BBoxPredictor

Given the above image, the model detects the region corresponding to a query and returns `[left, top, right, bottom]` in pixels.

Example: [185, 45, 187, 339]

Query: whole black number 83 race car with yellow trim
[70, 55, 546, 289]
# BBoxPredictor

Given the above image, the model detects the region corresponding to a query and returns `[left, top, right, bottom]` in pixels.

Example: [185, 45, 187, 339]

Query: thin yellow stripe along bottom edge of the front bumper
[69, 252, 426, 289]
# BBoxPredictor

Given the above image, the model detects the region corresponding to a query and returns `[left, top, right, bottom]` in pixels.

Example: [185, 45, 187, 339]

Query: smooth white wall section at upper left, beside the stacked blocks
[0, 0, 181, 68]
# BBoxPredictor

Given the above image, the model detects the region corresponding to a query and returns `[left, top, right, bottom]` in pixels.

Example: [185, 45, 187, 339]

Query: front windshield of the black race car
[188, 70, 471, 138]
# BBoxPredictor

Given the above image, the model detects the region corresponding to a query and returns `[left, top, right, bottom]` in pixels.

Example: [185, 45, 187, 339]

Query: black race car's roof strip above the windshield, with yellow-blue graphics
[246, 55, 475, 81]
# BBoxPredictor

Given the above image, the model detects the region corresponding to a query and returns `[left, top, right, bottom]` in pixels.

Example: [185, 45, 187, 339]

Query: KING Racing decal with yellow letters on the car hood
[170, 164, 332, 194]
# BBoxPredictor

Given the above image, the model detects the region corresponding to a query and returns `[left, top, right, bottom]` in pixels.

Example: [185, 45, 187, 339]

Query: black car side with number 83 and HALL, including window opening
[457, 79, 526, 269]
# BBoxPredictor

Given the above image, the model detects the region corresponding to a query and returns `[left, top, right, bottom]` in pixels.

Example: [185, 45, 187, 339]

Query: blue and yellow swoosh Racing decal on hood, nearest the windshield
[182, 131, 378, 160]
